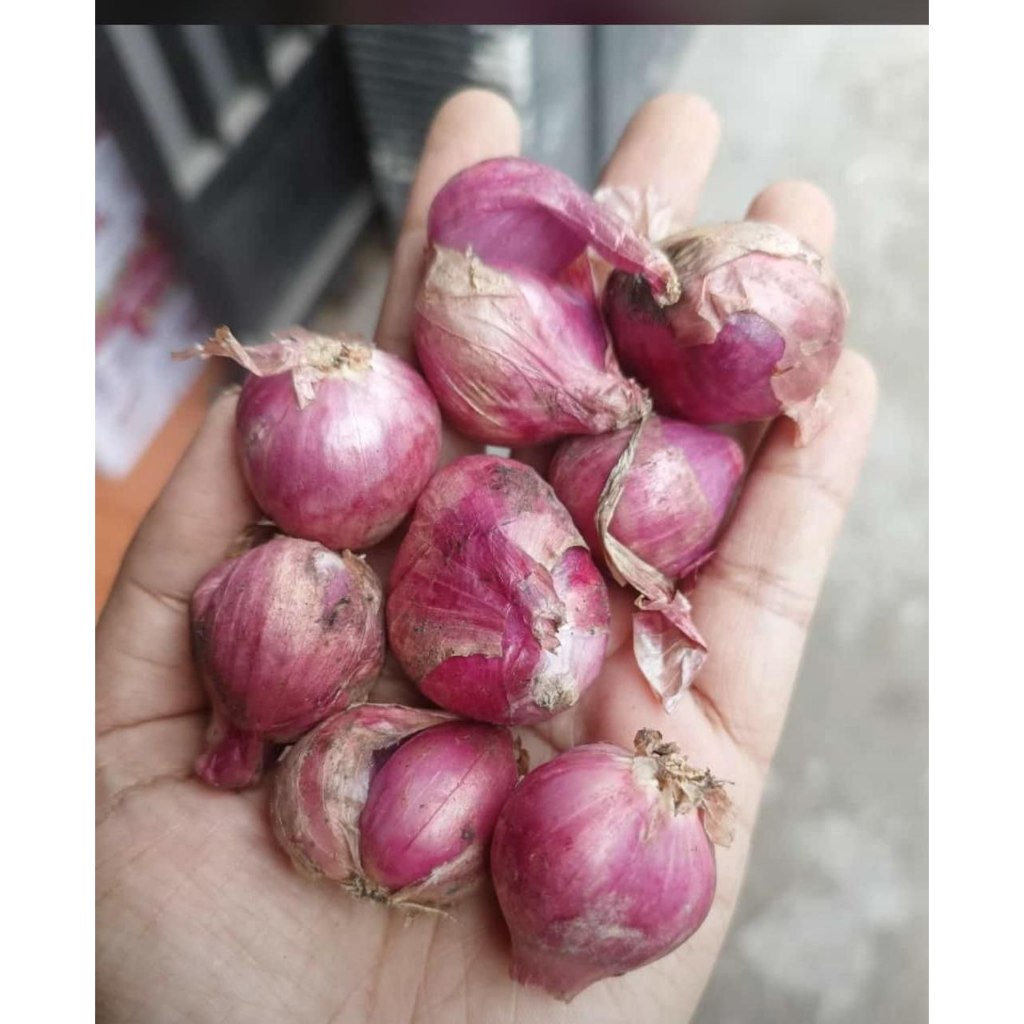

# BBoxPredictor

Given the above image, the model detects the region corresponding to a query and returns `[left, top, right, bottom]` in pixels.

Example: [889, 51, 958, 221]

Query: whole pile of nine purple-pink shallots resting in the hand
[178, 159, 846, 1000]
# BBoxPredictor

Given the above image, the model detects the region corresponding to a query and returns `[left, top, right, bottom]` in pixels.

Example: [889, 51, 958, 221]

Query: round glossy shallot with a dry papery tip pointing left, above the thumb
[179, 328, 441, 550]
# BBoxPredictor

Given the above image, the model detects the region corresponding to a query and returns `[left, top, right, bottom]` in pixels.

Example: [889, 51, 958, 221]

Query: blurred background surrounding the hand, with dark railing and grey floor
[96, 26, 928, 1024]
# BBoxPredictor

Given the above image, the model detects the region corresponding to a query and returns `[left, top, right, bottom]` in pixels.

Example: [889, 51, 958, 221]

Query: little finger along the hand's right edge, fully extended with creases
[689, 352, 877, 765]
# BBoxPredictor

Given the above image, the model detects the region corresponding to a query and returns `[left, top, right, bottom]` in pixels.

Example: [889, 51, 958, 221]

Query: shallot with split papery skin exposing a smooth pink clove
[270, 705, 518, 908]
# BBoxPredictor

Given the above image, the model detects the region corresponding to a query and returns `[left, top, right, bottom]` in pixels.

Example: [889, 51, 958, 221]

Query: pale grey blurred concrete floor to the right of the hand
[313, 26, 928, 1024]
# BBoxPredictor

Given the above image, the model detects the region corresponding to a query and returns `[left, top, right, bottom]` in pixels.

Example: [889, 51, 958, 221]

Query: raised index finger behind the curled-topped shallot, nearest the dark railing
[376, 89, 521, 358]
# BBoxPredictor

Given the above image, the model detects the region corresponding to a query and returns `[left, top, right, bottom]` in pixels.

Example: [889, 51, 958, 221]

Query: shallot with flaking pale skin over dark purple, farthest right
[603, 221, 849, 443]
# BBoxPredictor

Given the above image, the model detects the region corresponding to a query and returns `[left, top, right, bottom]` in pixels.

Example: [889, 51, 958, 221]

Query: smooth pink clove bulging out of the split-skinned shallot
[359, 722, 519, 897]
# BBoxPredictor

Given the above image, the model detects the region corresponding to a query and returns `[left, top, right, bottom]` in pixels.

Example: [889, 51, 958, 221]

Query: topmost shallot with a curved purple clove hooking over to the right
[414, 158, 678, 444]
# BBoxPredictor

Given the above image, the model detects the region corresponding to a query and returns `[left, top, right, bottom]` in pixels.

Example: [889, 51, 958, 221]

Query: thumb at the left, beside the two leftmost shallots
[96, 393, 258, 732]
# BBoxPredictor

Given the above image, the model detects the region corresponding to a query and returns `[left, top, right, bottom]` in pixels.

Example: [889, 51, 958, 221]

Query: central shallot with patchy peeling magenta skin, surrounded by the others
[387, 456, 610, 725]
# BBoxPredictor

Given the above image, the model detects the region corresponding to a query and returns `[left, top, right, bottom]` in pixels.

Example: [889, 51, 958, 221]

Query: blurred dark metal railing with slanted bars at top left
[96, 25, 374, 333]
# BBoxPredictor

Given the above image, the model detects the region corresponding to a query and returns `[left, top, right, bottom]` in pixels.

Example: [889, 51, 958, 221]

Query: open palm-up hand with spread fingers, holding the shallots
[96, 90, 874, 1024]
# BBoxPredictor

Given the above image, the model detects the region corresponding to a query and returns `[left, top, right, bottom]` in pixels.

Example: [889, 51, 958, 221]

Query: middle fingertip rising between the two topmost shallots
[601, 92, 721, 225]
